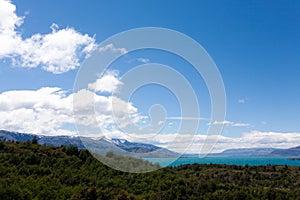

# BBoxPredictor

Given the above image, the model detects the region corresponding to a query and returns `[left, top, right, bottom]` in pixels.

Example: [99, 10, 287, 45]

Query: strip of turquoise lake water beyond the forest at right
[145, 156, 300, 166]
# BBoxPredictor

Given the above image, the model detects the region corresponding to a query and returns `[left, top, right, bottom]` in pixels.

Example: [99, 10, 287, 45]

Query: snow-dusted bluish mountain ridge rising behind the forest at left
[0, 130, 179, 158]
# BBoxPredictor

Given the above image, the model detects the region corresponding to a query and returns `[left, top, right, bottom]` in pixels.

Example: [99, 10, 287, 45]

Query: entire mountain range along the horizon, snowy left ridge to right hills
[0, 130, 300, 158]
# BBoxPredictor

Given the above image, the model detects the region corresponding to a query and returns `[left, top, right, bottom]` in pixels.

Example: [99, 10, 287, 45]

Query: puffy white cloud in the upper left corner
[0, 0, 96, 74]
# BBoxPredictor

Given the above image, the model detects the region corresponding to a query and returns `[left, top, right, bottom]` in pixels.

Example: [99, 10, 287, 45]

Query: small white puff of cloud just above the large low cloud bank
[88, 71, 123, 93]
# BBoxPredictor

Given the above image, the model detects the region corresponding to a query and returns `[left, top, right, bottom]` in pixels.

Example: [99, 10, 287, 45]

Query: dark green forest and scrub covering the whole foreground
[0, 141, 300, 200]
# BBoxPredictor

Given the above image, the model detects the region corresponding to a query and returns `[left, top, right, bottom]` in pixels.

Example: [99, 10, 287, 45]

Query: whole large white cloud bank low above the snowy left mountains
[0, 87, 143, 136]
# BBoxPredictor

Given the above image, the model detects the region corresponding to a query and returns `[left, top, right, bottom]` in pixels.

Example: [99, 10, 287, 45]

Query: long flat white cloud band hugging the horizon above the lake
[132, 131, 300, 153]
